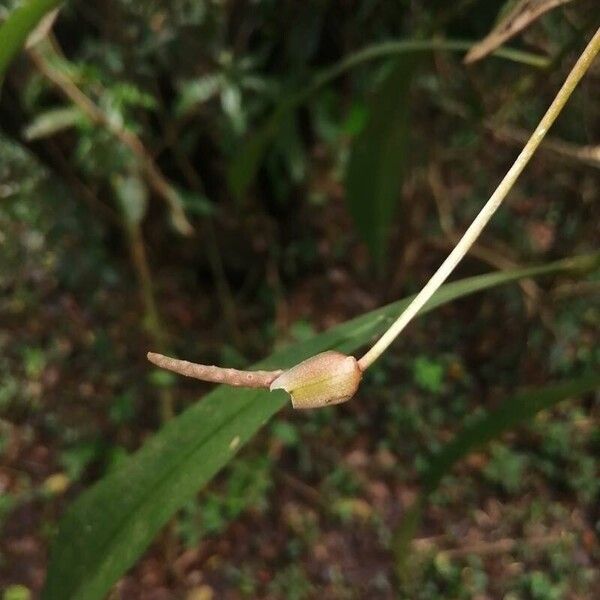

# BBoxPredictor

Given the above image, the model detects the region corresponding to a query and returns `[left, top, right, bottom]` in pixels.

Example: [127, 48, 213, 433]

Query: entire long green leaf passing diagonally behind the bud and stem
[43, 255, 599, 600]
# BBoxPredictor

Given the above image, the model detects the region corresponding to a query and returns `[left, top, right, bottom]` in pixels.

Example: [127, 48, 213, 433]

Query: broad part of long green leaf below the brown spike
[43, 388, 286, 600]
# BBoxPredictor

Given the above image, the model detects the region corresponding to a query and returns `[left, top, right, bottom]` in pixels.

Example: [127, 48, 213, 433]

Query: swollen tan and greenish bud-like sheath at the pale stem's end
[270, 350, 362, 409]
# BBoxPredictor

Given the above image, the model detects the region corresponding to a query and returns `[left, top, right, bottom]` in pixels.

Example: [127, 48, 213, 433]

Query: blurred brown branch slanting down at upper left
[29, 39, 193, 235]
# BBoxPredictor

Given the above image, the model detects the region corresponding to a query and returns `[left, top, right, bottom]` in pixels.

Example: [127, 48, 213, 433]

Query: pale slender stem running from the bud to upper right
[358, 28, 600, 371]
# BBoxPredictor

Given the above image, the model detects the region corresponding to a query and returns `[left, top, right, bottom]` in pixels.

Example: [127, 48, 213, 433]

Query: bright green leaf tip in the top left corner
[0, 0, 62, 82]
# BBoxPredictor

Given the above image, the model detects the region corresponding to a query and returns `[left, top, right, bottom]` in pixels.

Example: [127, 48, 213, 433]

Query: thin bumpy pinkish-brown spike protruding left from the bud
[147, 352, 283, 389]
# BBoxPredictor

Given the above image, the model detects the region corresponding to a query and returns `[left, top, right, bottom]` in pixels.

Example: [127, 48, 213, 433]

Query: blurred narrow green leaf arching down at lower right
[394, 373, 600, 578]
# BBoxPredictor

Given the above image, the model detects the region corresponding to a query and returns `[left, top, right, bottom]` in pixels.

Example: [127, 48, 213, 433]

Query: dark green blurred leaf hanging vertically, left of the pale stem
[346, 58, 415, 268]
